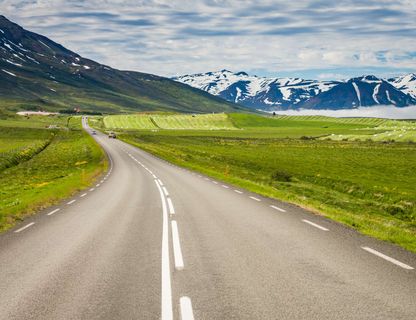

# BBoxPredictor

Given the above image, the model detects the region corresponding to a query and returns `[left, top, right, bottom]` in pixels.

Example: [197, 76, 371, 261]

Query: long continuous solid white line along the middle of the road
[155, 180, 173, 320]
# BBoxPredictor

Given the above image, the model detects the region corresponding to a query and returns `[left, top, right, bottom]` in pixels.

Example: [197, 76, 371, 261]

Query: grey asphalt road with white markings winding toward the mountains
[0, 119, 416, 320]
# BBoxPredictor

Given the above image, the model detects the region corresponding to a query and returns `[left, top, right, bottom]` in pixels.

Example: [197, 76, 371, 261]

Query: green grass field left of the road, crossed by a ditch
[0, 116, 107, 231]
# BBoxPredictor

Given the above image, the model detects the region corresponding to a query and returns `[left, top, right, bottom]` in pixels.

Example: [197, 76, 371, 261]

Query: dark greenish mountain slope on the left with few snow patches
[0, 16, 241, 112]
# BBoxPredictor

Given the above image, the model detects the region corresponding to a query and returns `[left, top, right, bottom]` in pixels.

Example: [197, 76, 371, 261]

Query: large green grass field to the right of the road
[113, 114, 416, 252]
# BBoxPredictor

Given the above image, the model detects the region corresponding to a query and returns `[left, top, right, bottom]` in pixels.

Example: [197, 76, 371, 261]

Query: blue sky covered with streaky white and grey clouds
[0, 0, 416, 79]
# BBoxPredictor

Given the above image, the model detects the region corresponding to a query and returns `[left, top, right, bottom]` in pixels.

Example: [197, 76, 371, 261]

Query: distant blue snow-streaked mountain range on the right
[172, 70, 416, 110]
